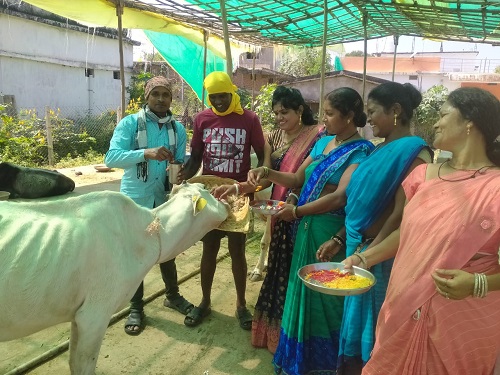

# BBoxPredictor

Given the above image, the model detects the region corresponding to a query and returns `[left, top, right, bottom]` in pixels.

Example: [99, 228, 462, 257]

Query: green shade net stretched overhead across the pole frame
[177, 0, 500, 46]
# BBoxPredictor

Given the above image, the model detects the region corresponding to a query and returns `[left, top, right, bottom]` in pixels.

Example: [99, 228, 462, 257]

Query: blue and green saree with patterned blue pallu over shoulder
[273, 140, 373, 375]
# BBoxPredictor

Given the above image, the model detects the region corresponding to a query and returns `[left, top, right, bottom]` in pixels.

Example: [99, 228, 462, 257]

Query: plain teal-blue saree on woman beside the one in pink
[338, 136, 426, 368]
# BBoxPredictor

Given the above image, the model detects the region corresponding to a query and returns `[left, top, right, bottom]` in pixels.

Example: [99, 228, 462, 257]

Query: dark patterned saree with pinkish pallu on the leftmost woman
[251, 126, 321, 354]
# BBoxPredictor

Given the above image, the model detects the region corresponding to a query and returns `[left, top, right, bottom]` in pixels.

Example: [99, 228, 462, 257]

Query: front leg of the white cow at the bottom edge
[69, 301, 112, 375]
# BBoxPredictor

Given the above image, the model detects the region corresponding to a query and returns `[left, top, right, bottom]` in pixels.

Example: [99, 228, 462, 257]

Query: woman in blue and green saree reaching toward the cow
[248, 88, 373, 375]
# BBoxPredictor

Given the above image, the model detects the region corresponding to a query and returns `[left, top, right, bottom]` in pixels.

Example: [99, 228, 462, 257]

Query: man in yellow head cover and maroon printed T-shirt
[180, 72, 265, 330]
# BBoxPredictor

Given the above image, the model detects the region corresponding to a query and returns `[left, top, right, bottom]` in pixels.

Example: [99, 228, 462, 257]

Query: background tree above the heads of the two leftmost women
[279, 47, 333, 77]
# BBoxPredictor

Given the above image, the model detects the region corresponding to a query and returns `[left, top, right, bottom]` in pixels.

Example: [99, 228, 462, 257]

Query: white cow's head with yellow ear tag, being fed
[153, 182, 230, 263]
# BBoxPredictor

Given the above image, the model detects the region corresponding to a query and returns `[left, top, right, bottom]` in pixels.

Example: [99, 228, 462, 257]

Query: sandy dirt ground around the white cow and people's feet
[0, 166, 273, 375]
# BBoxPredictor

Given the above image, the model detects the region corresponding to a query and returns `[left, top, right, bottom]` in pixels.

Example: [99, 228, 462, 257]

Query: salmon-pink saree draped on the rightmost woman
[363, 165, 500, 375]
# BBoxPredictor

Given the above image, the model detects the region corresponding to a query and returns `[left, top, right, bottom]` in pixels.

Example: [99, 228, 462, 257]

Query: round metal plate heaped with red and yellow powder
[298, 262, 376, 296]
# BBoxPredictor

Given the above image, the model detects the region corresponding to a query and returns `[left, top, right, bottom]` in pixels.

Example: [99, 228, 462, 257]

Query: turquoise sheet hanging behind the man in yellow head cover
[144, 30, 226, 100]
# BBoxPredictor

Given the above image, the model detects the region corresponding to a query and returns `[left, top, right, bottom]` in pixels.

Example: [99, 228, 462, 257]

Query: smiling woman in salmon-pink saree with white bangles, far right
[345, 87, 500, 375]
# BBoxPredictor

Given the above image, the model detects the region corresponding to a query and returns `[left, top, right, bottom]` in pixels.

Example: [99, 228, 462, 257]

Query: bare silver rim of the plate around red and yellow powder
[297, 262, 377, 296]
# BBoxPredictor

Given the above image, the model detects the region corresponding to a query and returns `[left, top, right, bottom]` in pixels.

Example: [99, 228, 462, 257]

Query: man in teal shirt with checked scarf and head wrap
[104, 76, 193, 335]
